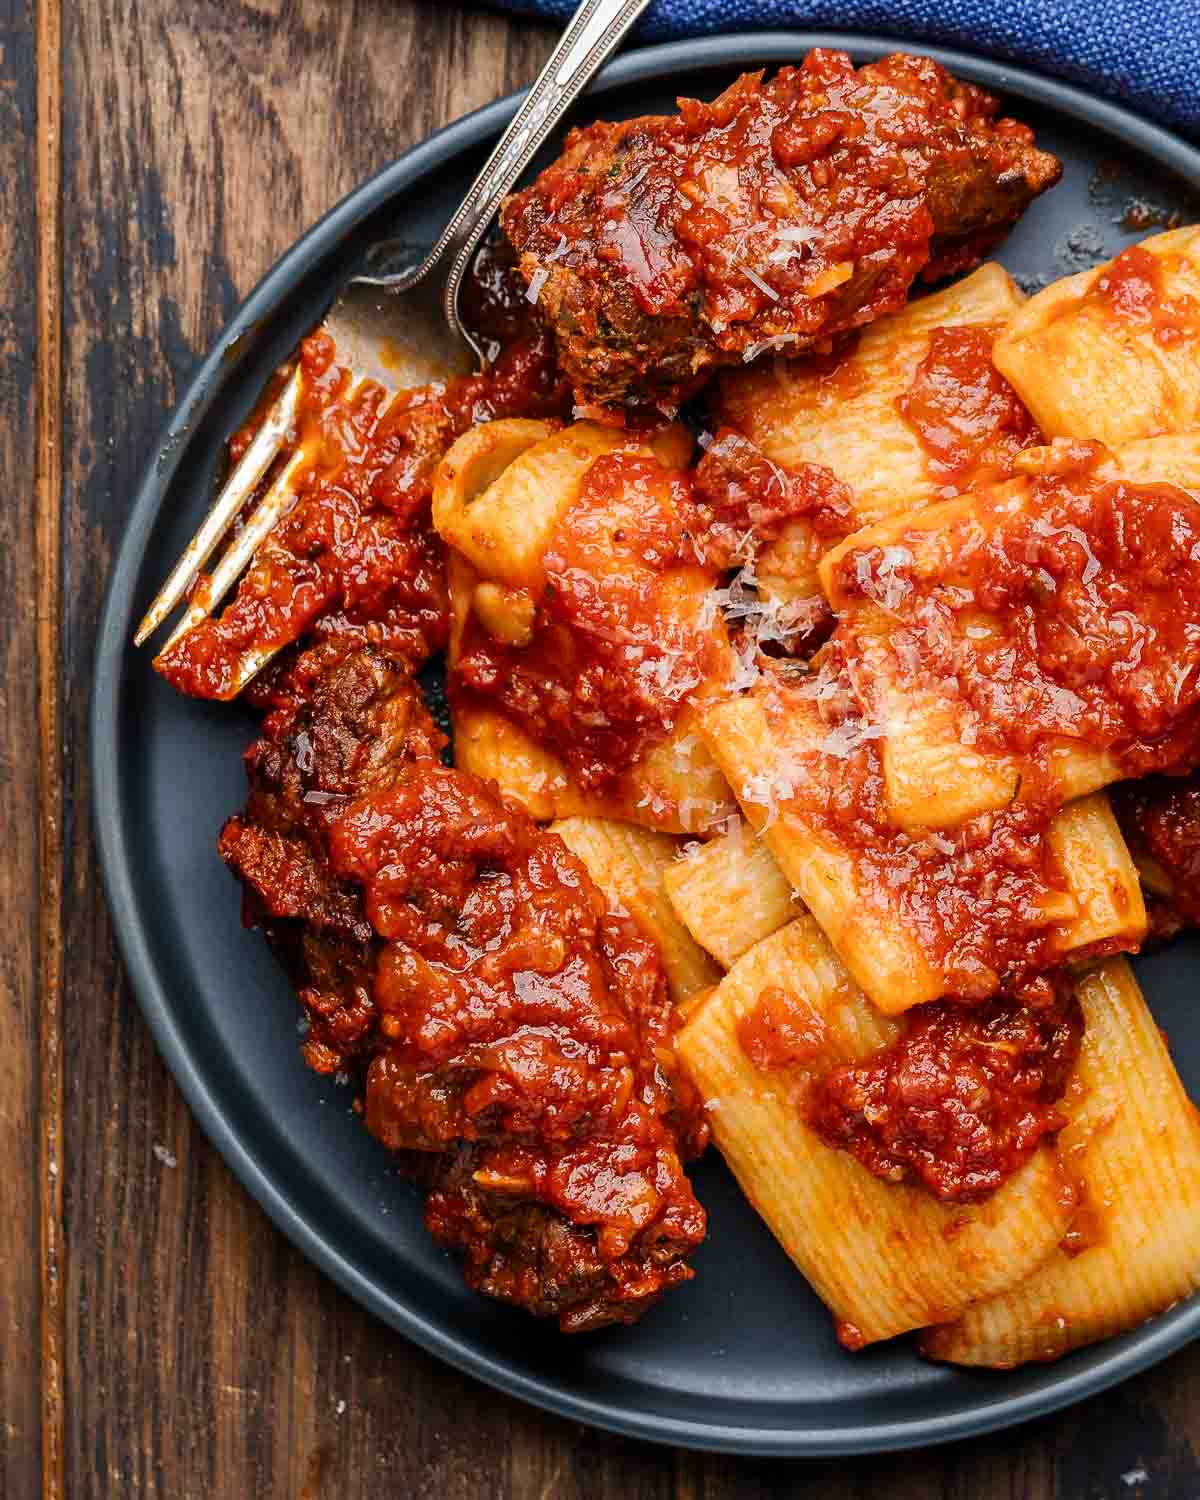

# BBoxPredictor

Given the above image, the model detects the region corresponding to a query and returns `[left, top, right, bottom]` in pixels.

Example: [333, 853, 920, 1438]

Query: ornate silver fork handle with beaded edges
[426, 0, 650, 353]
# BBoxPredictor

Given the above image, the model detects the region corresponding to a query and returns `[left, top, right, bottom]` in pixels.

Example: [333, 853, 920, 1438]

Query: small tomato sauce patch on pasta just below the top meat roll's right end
[896, 327, 1044, 497]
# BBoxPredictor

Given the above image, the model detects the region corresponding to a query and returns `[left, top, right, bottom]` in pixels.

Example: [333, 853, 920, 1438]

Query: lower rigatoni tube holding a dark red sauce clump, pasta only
[677, 917, 1070, 1349]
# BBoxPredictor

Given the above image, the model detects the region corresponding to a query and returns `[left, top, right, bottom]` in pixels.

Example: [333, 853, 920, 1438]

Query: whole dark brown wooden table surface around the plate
[14, 0, 1200, 1500]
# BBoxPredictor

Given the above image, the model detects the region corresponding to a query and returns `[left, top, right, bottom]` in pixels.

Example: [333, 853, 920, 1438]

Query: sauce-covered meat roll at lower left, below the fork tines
[221, 642, 707, 1331]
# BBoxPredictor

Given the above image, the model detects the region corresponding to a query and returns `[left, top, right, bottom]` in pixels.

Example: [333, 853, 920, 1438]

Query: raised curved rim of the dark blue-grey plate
[90, 29, 1200, 1458]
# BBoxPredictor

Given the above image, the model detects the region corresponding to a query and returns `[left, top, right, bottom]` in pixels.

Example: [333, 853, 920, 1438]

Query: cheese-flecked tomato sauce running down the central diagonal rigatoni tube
[752, 669, 1086, 1005]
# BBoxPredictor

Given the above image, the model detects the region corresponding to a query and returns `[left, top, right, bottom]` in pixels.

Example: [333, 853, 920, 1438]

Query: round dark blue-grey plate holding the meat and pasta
[92, 33, 1200, 1454]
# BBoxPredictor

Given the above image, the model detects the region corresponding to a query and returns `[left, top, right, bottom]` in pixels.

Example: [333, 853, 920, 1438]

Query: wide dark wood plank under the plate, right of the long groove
[51, 0, 1200, 1500]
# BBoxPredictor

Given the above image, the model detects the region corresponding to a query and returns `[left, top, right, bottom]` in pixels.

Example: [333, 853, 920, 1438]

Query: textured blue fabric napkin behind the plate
[483, 0, 1200, 137]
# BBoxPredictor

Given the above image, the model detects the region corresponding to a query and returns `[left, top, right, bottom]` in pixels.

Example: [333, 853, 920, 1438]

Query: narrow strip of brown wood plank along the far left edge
[0, 0, 42, 1496]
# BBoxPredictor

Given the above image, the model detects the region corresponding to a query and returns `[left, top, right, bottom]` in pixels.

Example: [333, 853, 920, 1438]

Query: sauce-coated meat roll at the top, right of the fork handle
[501, 50, 1061, 408]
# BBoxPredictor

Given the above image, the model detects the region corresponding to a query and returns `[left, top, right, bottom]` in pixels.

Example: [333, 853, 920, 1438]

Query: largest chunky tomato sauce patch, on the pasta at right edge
[833, 444, 1200, 795]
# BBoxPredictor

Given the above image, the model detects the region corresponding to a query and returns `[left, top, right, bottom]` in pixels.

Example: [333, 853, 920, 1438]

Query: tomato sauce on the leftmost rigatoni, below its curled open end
[450, 452, 714, 788]
